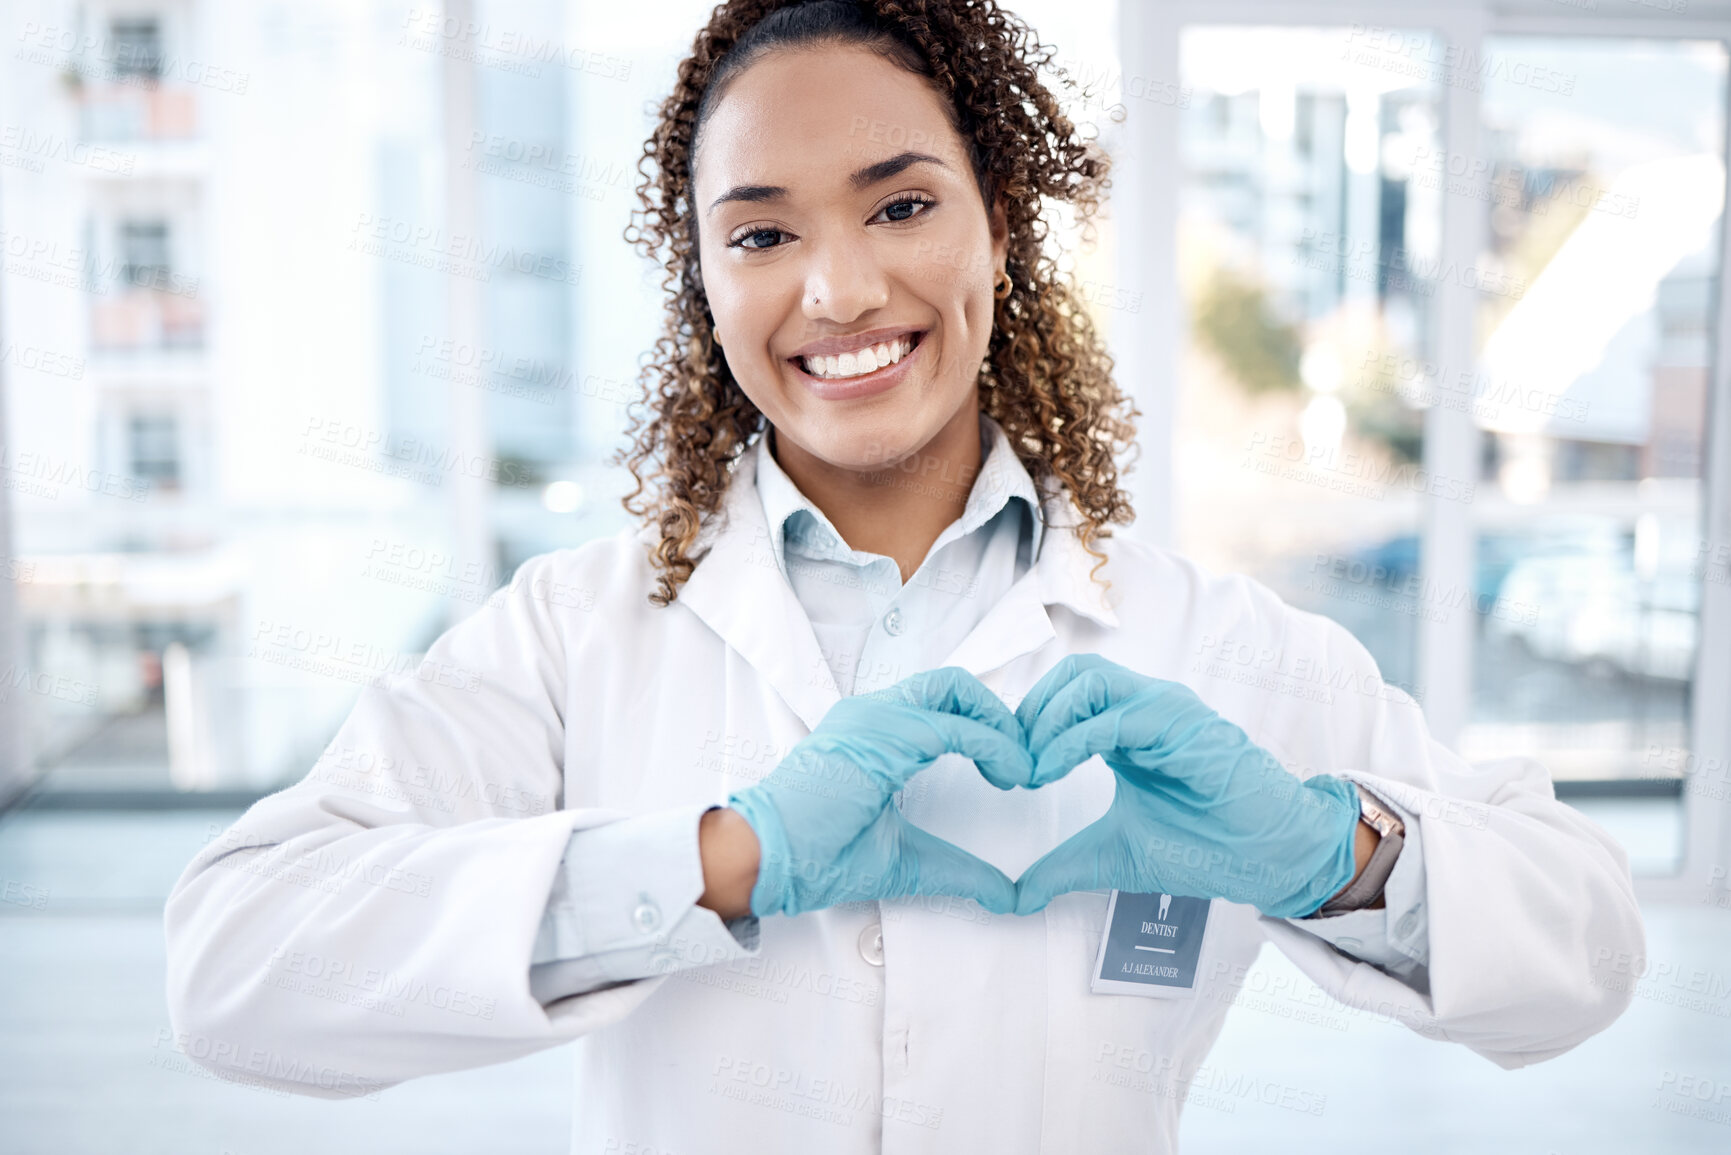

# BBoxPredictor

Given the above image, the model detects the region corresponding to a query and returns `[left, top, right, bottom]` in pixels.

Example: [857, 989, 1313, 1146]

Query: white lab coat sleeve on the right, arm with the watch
[1245, 584, 1644, 1068]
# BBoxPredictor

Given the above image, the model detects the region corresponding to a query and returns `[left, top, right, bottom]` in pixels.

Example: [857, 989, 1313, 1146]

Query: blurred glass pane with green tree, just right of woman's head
[1174, 26, 1447, 689]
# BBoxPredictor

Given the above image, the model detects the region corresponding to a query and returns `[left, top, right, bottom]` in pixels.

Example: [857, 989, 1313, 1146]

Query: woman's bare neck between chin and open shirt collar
[770, 403, 981, 582]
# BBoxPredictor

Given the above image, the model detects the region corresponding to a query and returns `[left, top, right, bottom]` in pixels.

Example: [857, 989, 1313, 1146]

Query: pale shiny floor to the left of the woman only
[0, 812, 571, 1155]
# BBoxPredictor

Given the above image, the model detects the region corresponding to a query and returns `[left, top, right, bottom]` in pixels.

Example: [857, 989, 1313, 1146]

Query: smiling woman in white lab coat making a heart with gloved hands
[168, 0, 1643, 1152]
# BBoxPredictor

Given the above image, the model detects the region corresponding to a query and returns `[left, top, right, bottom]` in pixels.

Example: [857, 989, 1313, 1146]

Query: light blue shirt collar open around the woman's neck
[751, 412, 1046, 575]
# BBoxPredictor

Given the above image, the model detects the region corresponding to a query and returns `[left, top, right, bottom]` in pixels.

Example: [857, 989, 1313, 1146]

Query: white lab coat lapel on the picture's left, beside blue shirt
[675, 454, 841, 729]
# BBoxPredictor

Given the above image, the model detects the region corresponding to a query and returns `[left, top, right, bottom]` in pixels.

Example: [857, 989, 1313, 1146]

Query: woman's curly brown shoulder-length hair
[615, 0, 1137, 606]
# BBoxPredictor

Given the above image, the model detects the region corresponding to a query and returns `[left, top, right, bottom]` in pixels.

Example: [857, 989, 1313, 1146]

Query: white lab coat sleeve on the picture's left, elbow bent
[164, 554, 682, 1098]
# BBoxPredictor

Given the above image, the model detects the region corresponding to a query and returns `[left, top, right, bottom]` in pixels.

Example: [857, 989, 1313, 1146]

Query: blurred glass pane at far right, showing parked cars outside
[1461, 36, 1726, 796]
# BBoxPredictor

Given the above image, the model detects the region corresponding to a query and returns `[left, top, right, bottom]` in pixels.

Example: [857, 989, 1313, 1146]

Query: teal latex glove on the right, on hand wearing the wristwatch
[1016, 655, 1359, 918]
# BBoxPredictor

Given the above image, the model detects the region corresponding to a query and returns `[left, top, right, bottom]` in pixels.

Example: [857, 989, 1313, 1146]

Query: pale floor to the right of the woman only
[1184, 907, 1731, 1155]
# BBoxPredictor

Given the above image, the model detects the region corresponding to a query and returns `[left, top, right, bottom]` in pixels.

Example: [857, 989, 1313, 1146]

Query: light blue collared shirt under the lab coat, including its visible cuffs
[530, 414, 1425, 1004]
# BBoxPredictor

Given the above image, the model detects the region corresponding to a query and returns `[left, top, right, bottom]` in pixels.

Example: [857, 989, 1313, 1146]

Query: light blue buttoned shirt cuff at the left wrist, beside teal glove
[530, 805, 758, 1004]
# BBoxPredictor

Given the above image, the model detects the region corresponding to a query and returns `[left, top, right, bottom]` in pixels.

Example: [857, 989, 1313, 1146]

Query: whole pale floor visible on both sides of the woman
[0, 812, 1731, 1155]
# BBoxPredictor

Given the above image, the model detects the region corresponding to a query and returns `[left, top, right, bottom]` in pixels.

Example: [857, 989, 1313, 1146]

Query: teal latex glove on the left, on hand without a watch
[727, 667, 1033, 914]
